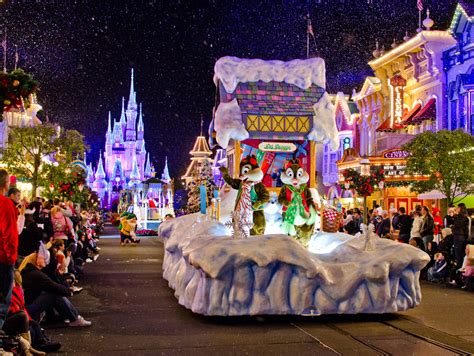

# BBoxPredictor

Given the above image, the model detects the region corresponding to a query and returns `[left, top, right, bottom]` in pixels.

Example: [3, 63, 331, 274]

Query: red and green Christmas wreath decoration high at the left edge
[0, 69, 38, 115]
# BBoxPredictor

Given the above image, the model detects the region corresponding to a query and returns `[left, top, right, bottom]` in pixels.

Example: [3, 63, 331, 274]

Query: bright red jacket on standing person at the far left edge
[0, 195, 18, 265]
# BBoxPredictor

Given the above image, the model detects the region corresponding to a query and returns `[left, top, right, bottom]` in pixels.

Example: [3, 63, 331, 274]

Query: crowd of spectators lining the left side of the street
[0, 169, 100, 355]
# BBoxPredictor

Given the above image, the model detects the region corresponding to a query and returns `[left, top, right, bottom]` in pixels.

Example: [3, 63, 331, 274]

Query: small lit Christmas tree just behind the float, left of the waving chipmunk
[186, 161, 218, 214]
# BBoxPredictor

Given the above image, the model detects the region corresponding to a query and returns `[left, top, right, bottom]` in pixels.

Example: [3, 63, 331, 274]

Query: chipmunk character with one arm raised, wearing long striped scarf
[220, 155, 269, 235]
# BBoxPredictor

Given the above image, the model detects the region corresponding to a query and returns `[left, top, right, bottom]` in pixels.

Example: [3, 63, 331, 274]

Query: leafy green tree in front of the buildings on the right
[402, 129, 474, 205]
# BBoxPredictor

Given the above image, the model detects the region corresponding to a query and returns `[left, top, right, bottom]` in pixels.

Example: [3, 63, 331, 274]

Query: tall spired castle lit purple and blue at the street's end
[87, 69, 170, 206]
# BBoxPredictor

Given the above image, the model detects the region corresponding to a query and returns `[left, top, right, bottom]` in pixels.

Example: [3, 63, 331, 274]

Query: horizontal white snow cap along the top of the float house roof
[214, 57, 326, 93]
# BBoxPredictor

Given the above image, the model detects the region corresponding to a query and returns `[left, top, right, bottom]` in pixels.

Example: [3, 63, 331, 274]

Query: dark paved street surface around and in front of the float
[48, 229, 474, 356]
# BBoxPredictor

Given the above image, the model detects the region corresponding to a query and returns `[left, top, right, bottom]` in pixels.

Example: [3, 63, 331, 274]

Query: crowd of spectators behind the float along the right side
[341, 203, 474, 290]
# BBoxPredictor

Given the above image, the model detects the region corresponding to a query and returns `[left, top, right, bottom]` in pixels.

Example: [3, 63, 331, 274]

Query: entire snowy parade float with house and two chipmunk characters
[158, 57, 429, 316]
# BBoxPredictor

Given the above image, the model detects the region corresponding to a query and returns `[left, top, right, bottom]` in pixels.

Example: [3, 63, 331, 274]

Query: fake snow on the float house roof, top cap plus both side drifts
[213, 57, 339, 150]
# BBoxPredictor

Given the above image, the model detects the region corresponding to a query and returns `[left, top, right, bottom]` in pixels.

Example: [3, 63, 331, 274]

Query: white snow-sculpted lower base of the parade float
[159, 214, 429, 315]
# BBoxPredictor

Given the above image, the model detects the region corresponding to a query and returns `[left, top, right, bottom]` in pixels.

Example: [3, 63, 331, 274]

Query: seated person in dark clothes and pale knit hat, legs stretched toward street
[20, 245, 91, 326]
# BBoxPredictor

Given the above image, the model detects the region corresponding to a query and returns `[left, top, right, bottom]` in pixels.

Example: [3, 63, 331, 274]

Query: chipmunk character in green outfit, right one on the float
[278, 159, 317, 246]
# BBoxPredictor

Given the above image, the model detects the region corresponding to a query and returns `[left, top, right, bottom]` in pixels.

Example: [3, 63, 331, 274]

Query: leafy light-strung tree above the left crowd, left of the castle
[2, 124, 86, 197]
